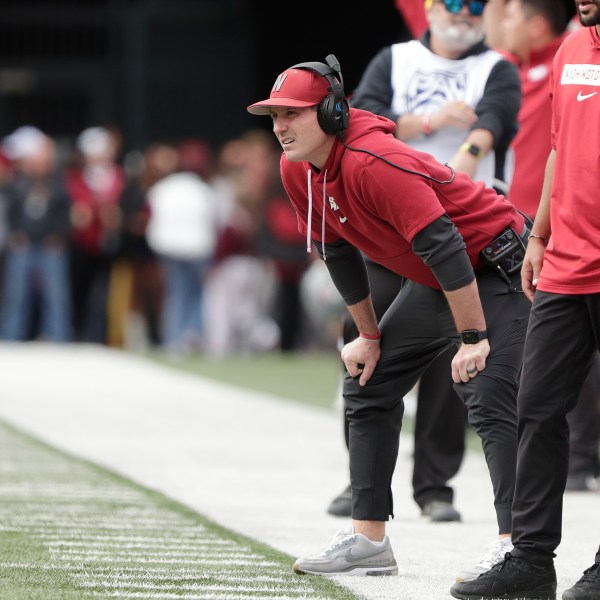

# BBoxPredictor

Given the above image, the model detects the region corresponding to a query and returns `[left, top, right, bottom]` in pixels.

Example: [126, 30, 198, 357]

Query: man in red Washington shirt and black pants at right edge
[451, 0, 600, 600]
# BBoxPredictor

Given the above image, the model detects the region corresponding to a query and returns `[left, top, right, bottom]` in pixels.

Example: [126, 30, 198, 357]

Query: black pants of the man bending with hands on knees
[344, 269, 531, 533]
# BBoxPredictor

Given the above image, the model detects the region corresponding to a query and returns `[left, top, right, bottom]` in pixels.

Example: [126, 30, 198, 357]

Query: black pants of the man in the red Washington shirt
[513, 291, 600, 562]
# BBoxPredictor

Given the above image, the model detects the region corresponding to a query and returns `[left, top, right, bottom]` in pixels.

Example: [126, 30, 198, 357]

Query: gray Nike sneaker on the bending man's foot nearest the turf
[294, 529, 398, 575]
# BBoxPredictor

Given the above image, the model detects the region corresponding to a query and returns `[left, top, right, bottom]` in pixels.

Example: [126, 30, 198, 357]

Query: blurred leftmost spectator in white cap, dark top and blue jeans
[0, 125, 71, 342]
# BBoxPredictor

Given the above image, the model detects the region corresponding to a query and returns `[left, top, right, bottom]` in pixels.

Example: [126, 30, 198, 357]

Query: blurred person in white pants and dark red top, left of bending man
[205, 130, 281, 357]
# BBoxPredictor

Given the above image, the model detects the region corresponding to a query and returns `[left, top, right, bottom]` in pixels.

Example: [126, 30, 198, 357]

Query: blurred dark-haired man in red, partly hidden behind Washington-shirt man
[487, 0, 600, 491]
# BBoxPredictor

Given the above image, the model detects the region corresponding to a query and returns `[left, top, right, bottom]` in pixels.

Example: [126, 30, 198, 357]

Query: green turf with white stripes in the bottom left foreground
[0, 421, 356, 600]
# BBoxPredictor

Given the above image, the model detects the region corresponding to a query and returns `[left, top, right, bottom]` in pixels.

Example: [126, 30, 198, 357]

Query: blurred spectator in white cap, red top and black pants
[66, 127, 126, 344]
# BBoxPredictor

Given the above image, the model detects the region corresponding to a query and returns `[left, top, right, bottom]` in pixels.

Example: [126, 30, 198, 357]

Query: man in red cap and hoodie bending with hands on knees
[248, 55, 529, 575]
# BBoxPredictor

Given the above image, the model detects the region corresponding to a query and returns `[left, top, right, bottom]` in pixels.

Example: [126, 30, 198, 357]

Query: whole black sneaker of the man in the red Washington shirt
[450, 552, 556, 600]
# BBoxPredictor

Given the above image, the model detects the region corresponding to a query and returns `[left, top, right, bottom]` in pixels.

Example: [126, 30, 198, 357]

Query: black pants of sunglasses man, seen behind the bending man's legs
[343, 259, 466, 508]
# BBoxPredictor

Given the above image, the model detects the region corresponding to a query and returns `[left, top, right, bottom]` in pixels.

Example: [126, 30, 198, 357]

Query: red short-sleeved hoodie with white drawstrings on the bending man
[280, 108, 524, 289]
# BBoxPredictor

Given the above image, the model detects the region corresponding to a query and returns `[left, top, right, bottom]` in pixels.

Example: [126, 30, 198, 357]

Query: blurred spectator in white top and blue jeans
[146, 140, 218, 354]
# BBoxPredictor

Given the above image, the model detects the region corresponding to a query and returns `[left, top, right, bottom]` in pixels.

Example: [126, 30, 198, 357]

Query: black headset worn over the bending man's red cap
[290, 54, 350, 139]
